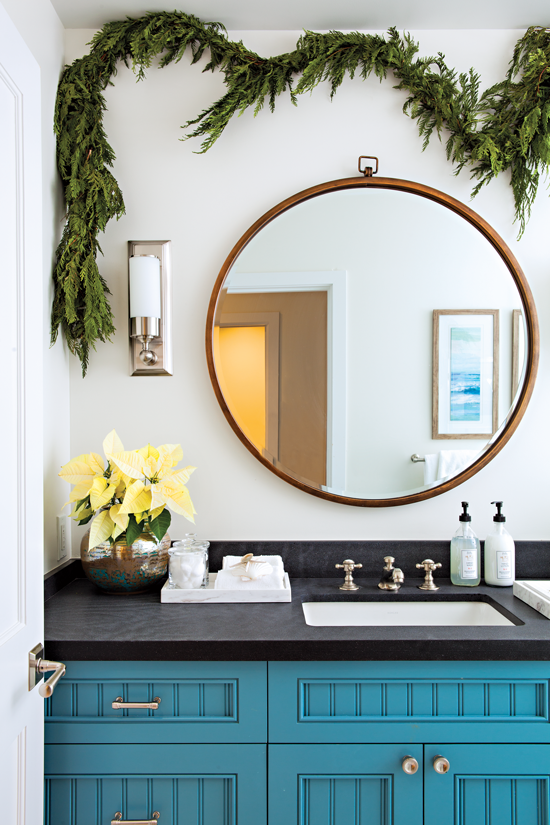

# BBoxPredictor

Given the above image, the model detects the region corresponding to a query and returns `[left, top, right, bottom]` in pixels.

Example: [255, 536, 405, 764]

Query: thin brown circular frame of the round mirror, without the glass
[206, 177, 540, 507]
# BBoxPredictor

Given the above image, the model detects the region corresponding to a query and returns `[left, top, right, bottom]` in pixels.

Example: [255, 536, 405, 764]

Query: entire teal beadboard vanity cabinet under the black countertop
[45, 661, 550, 825]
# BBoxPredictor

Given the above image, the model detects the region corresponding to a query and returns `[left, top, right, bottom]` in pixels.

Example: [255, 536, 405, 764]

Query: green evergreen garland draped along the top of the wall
[51, 11, 550, 375]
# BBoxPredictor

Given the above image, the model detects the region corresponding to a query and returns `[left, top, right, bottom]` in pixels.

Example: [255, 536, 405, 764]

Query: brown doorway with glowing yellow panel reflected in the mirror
[215, 291, 328, 487]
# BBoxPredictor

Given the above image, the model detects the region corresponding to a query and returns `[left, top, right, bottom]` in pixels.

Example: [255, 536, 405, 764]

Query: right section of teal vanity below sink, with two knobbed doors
[268, 662, 550, 825]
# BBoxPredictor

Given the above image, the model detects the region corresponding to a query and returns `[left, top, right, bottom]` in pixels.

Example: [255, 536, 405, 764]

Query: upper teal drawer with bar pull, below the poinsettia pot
[45, 662, 267, 744]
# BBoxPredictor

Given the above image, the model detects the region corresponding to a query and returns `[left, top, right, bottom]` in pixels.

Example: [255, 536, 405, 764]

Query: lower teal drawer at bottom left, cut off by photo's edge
[44, 745, 266, 825]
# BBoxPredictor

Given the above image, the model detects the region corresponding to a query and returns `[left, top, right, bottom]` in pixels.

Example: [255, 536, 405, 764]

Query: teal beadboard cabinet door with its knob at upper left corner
[424, 745, 550, 825]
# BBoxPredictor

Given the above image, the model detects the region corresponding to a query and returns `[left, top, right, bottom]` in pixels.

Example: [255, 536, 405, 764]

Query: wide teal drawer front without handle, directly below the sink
[269, 662, 550, 743]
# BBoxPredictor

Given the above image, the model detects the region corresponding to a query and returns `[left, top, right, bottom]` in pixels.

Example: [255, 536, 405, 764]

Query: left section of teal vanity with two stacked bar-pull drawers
[45, 662, 267, 825]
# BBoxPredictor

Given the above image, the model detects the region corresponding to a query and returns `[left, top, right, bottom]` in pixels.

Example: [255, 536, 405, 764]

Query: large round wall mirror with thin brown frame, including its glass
[206, 177, 538, 507]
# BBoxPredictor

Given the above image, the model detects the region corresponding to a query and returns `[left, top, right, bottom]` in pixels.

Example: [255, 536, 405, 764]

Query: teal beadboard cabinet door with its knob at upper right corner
[268, 745, 422, 825]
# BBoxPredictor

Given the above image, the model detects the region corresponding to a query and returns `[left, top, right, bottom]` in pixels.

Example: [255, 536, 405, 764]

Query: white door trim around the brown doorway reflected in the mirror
[231, 270, 347, 495]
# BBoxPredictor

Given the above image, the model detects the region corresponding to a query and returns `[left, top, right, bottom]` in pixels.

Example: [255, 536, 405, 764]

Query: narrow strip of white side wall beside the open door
[2, 0, 70, 572]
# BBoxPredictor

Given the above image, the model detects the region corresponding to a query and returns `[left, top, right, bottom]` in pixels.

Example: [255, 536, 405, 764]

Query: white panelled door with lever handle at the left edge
[0, 5, 44, 825]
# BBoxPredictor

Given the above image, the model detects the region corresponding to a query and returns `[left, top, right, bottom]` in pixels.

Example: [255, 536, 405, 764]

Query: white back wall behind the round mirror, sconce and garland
[66, 29, 550, 554]
